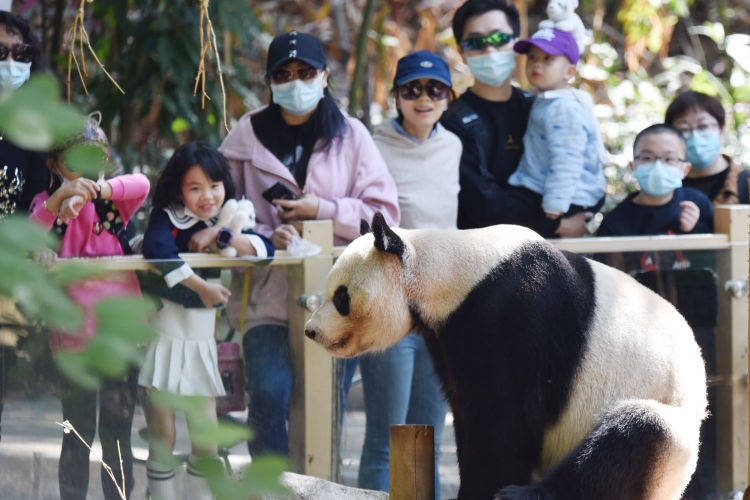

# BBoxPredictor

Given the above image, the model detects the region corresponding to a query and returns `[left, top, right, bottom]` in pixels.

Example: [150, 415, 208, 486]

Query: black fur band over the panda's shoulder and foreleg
[424, 242, 596, 498]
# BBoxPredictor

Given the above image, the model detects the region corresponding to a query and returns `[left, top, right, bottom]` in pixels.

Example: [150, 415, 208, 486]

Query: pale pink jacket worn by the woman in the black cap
[219, 108, 400, 330]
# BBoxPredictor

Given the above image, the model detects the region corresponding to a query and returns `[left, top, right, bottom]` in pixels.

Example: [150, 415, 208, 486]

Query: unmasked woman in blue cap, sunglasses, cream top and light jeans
[358, 51, 461, 498]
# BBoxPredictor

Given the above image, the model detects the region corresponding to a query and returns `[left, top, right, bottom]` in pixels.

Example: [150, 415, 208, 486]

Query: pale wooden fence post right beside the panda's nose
[288, 220, 338, 481]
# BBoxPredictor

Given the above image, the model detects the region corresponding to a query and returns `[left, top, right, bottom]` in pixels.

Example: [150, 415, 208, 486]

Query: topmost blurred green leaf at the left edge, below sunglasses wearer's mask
[0, 74, 83, 151]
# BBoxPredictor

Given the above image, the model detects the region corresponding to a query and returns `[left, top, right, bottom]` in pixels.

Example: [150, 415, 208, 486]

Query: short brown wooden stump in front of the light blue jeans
[388, 425, 435, 500]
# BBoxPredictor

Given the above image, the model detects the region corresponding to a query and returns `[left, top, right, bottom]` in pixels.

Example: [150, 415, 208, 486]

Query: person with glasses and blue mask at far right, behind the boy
[664, 90, 750, 205]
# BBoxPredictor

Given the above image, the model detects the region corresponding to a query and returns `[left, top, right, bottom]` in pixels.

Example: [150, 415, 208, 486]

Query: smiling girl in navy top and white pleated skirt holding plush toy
[138, 142, 274, 499]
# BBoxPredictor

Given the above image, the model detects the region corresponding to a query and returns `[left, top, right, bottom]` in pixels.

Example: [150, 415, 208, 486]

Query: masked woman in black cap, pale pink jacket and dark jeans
[220, 31, 399, 455]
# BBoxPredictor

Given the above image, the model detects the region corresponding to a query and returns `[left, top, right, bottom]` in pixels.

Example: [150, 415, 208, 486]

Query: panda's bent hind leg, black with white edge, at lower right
[497, 400, 701, 500]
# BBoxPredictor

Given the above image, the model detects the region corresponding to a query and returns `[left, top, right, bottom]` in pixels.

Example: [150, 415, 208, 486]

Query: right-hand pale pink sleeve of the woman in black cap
[317, 119, 401, 241]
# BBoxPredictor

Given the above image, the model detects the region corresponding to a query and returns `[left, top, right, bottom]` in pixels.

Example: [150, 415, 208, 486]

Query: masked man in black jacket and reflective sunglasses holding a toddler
[442, 0, 591, 237]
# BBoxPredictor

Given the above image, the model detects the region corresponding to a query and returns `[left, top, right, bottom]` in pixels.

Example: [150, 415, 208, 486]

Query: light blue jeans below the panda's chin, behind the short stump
[358, 334, 448, 498]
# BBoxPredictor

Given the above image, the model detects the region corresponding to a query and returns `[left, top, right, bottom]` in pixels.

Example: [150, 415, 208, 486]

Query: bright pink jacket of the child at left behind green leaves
[31, 174, 149, 351]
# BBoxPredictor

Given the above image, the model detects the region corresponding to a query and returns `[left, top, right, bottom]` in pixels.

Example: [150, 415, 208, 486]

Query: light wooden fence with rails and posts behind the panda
[47, 205, 750, 498]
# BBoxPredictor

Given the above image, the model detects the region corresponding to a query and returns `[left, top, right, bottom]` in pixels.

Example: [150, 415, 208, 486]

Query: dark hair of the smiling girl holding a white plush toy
[153, 142, 234, 209]
